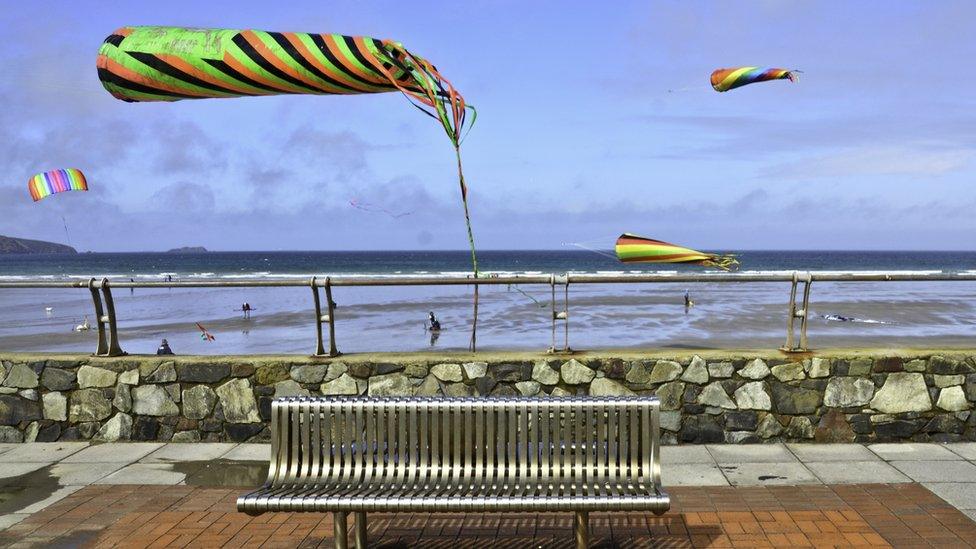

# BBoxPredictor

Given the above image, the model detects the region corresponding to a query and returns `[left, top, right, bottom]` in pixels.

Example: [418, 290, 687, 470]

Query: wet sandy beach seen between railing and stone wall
[0, 282, 976, 354]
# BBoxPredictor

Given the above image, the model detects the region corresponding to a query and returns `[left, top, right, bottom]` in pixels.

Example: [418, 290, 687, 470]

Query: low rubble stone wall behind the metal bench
[0, 351, 976, 444]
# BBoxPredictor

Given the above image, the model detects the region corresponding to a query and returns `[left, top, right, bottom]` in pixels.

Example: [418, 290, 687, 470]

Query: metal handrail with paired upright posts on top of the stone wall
[0, 272, 976, 357]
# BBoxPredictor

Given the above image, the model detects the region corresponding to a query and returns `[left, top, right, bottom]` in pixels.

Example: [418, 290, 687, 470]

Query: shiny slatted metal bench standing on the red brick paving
[237, 397, 671, 548]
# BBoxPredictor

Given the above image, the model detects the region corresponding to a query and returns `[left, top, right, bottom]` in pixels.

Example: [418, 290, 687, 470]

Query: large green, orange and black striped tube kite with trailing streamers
[98, 27, 478, 275]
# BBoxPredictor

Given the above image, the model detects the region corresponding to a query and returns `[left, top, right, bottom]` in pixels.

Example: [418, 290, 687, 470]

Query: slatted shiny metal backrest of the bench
[268, 397, 661, 488]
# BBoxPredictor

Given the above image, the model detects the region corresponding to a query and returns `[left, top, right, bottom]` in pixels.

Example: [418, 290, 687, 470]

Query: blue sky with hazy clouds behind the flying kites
[0, 0, 976, 252]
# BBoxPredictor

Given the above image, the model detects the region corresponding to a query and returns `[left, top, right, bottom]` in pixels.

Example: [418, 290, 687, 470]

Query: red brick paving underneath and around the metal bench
[0, 484, 976, 549]
